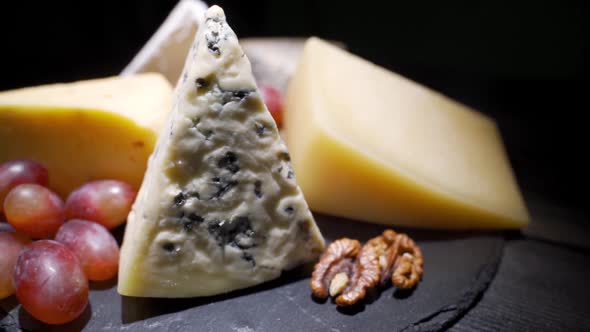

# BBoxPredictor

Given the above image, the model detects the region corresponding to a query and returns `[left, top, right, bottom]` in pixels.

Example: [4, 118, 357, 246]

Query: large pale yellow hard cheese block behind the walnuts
[285, 38, 529, 229]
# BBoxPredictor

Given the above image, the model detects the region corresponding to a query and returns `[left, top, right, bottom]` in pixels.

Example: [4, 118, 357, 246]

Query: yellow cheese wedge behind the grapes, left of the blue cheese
[0, 74, 172, 197]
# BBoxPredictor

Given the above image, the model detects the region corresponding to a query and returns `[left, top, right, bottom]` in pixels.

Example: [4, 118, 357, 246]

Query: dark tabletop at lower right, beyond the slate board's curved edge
[450, 238, 590, 332]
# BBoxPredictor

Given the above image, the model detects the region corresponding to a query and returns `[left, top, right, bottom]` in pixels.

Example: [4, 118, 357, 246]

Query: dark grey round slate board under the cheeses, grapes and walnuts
[0, 215, 504, 332]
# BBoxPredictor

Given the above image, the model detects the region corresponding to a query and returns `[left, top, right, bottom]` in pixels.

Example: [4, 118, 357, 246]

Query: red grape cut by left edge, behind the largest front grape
[0, 232, 31, 299]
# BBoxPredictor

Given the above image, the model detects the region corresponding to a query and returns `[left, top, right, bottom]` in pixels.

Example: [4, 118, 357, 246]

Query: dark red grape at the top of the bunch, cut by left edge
[0, 160, 49, 214]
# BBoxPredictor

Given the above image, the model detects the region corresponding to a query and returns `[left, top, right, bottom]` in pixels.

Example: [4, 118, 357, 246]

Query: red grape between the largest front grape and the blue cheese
[55, 219, 119, 281]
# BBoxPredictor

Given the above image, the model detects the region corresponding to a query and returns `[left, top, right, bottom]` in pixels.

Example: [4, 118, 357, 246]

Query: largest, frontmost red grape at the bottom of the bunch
[14, 240, 88, 324]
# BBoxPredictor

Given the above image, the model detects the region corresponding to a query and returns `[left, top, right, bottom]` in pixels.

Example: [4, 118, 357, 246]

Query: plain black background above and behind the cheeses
[0, 0, 589, 211]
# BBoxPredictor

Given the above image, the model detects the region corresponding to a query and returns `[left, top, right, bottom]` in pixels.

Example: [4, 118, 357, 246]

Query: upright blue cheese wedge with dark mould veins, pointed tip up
[118, 6, 324, 297]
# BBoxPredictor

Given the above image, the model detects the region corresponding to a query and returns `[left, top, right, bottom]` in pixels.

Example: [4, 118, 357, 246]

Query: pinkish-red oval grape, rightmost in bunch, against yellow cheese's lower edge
[66, 180, 137, 229]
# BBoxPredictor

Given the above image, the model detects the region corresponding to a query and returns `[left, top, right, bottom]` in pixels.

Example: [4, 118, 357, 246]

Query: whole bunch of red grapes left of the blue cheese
[0, 160, 136, 324]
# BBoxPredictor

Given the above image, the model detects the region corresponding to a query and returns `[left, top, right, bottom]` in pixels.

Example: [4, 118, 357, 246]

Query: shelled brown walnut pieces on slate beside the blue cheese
[310, 229, 424, 306]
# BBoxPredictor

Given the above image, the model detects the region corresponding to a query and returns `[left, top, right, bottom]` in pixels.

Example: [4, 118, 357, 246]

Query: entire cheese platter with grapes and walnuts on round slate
[0, 0, 529, 331]
